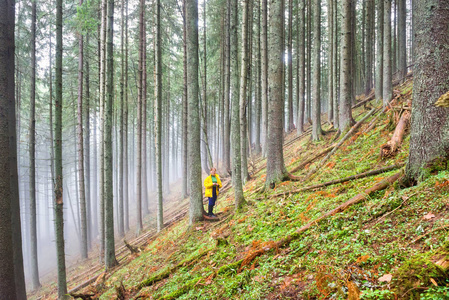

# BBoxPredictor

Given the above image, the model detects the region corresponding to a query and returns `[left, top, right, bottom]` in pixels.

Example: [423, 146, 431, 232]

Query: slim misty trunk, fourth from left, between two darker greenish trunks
[77, 0, 88, 259]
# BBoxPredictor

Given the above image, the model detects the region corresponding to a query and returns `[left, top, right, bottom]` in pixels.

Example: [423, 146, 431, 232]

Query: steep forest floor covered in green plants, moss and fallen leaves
[31, 80, 449, 299]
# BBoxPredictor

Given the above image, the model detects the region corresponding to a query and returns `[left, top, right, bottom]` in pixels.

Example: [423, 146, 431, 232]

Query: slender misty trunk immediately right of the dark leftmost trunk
[29, 1, 41, 290]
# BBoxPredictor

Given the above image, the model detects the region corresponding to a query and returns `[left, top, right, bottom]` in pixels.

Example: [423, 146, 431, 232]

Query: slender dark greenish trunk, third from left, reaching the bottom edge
[53, 0, 67, 292]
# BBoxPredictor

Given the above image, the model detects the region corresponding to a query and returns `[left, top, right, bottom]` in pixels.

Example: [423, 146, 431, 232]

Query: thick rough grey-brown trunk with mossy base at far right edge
[406, 0, 449, 184]
